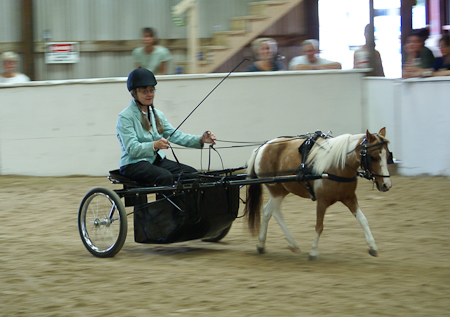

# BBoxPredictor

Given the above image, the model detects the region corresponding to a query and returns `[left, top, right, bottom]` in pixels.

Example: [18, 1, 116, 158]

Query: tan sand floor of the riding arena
[0, 176, 450, 316]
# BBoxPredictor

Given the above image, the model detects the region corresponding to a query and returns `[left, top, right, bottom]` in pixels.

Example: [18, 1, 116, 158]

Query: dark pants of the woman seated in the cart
[120, 157, 197, 186]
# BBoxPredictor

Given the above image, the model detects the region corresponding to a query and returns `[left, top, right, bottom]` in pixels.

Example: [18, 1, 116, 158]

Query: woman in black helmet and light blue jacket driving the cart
[117, 67, 216, 186]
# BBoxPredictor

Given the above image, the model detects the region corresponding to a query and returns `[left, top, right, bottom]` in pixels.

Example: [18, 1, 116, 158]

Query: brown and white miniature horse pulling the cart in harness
[245, 128, 392, 260]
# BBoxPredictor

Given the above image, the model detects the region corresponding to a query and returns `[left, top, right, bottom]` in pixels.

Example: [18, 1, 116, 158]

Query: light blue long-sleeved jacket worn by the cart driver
[117, 101, 203, 167]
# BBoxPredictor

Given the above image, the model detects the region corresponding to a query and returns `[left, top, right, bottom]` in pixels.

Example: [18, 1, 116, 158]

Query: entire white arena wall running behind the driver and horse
[0, 70, 450, 176]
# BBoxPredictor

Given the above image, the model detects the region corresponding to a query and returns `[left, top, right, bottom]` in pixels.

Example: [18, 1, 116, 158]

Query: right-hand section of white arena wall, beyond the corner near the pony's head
[364, 77, 450, 176]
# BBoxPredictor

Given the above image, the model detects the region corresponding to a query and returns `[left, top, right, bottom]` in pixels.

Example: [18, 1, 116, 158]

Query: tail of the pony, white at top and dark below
[244, 150, 262, 235]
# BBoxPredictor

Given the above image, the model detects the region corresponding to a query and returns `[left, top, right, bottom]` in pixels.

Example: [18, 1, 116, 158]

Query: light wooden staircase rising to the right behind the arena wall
[197, 0, 303, 73]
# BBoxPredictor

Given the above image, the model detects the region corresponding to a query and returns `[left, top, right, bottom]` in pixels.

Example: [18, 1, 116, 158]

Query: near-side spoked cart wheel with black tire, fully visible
[78, 187, 128, 258]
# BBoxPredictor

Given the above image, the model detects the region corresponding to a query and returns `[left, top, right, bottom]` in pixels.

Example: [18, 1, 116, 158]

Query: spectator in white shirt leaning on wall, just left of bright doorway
[289, 39, 342, 70]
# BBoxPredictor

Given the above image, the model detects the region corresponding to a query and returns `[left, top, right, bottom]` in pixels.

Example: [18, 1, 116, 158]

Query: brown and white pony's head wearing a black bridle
[361, 128, 392, 192]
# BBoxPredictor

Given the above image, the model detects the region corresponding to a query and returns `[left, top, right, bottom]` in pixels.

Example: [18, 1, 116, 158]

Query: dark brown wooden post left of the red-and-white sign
[21, 0, 35, 80]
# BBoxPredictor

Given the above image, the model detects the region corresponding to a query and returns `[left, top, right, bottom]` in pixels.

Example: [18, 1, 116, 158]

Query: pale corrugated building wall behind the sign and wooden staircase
[0, 0, 303, 80]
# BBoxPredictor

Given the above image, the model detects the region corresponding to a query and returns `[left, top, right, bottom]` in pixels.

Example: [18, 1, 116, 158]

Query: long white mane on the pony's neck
[306, 134, 364, 174]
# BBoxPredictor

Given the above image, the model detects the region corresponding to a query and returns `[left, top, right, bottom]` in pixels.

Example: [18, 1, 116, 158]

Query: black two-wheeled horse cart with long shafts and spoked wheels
[78, 168, 322, 257]
